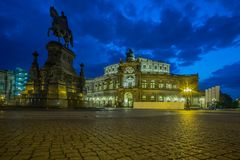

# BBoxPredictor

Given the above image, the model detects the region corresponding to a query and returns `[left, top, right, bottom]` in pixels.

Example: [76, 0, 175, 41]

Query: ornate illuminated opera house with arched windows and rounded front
[85, 49, 204, 107]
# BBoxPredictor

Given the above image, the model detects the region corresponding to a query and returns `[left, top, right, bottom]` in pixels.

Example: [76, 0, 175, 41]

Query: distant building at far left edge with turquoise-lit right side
[0, 68, 28, 103]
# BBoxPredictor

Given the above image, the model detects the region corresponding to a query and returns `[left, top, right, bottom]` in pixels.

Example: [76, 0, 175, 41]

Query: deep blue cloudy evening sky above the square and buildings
[0, 0, 240, 98]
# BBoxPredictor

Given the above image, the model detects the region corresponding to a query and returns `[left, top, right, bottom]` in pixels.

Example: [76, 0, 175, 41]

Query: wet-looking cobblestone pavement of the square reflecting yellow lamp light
[0, 110, 240, 160]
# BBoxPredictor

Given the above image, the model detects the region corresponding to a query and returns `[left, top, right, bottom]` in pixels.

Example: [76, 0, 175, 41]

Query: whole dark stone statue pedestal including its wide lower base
[21, 41, 83, 108]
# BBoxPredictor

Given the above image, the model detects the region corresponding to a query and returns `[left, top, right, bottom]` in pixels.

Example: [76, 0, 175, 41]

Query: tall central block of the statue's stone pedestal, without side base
[42, 42, 79, 107]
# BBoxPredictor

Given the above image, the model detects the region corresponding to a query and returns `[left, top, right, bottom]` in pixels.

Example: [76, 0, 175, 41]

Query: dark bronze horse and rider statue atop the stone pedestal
[48, 7, 73, 47]
